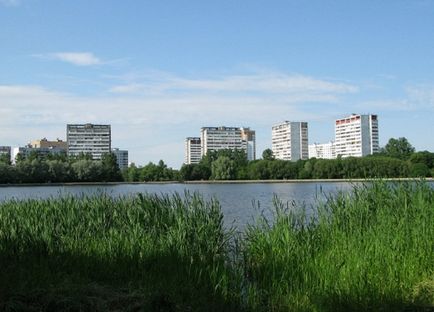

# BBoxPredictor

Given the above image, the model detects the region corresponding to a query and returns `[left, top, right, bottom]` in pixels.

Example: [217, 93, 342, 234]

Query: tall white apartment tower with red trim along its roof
[335, 114, 380, 157]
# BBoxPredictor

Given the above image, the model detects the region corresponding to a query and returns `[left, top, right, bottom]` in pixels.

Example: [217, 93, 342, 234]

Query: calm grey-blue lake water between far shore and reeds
[0, 182, 358, 228]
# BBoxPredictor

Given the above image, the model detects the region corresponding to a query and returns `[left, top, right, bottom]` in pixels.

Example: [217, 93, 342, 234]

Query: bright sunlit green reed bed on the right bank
[244, 182, 434, 311]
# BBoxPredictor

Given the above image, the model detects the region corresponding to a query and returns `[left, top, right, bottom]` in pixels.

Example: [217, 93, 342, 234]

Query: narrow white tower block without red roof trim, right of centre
[271, 121, 309, 161]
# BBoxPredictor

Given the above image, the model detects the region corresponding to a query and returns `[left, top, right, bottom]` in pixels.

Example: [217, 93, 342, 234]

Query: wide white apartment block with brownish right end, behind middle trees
[200, 126, 256, 160]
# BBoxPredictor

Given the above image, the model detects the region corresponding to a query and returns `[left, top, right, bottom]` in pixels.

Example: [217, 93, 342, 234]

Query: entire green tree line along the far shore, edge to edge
[0, 138, 434, 184]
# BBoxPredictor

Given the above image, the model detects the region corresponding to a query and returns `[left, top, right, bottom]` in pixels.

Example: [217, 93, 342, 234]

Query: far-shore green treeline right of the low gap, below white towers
[179, 138, 434, 181]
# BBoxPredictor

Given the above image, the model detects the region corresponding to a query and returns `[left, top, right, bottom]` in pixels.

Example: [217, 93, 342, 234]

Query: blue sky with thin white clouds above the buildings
[0, 0, 434, 168]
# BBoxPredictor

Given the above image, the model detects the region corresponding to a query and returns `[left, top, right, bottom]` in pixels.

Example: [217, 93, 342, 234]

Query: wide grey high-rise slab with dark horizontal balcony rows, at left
[66, 124, 111, 160]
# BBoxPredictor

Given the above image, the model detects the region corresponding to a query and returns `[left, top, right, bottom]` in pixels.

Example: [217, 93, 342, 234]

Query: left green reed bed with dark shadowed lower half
[0, 194, 239, 311]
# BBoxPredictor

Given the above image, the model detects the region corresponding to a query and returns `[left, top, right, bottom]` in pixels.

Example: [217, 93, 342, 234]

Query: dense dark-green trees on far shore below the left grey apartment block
[0, 153, 122, 184]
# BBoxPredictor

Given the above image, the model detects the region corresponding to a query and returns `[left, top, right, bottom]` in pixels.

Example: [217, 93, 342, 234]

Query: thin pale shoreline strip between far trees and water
[0, 178, 434, 188]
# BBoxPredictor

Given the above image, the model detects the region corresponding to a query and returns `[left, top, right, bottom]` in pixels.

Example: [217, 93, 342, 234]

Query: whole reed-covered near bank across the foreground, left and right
[0, 181, 434, 312]
